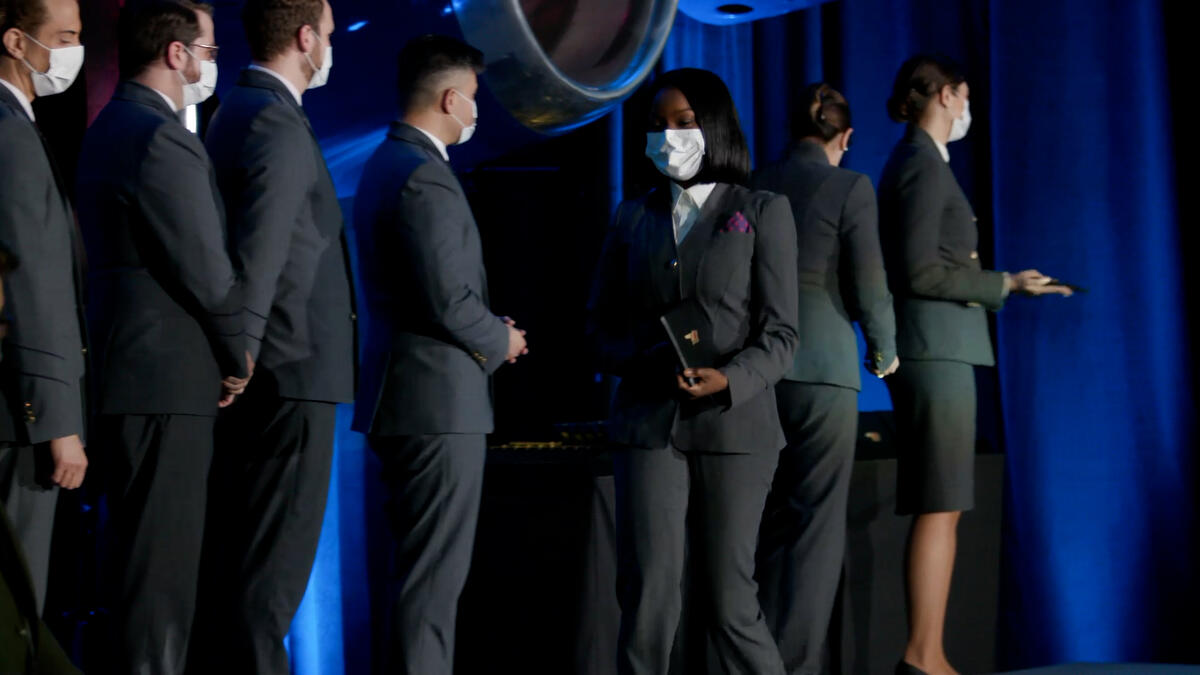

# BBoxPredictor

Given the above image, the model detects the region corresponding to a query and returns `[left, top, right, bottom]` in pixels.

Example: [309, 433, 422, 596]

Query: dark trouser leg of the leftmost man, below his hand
[0, 443, 59, 613]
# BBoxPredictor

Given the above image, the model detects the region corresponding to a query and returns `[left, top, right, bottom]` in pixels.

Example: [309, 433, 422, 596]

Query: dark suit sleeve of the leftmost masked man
[0, 120, 83, 443]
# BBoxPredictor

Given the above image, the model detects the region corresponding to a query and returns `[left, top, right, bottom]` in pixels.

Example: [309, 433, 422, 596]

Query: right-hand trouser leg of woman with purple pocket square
[688, 452, 784, 675]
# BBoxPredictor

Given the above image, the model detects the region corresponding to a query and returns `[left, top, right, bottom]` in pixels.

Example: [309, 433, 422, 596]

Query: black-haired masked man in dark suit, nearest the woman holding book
[354, 36, 526, 675]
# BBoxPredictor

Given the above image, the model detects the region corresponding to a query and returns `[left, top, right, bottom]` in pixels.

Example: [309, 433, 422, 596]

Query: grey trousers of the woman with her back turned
[758, 382, 858, 675]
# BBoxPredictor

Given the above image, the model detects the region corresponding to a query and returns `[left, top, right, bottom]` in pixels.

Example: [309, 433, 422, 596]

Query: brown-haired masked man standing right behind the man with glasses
[192, 0, 355, 675]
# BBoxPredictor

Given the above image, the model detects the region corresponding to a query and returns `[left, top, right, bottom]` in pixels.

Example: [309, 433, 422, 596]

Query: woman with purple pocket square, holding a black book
[588, 68, 797, 675]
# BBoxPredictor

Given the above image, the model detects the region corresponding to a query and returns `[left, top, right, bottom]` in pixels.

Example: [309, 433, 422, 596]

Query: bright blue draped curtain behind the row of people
[289, 0, 1200, 675]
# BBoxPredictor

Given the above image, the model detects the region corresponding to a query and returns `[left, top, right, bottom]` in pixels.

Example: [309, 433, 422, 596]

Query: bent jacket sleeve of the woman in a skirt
[894, 155, 1004, 310]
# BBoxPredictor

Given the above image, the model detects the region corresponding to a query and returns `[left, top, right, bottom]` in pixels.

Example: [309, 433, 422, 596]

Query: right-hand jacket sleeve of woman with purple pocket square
[721, 196, 799, 407]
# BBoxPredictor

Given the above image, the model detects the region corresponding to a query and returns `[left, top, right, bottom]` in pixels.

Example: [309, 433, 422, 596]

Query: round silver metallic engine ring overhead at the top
[454, 0, 678, 135]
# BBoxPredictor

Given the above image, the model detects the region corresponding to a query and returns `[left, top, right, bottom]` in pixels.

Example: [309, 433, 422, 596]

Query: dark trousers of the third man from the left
[192, 393, 337, 675]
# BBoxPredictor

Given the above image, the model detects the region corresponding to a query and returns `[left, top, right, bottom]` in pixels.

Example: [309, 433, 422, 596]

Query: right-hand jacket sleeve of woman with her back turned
[840, 175, 896, 368]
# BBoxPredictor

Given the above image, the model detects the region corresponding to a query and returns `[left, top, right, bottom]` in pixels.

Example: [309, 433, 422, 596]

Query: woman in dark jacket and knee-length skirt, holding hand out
[880, 55, 1070, 675]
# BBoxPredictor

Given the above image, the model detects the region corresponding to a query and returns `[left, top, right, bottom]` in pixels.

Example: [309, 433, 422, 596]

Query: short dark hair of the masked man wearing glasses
[116, 0, 212, 79]
